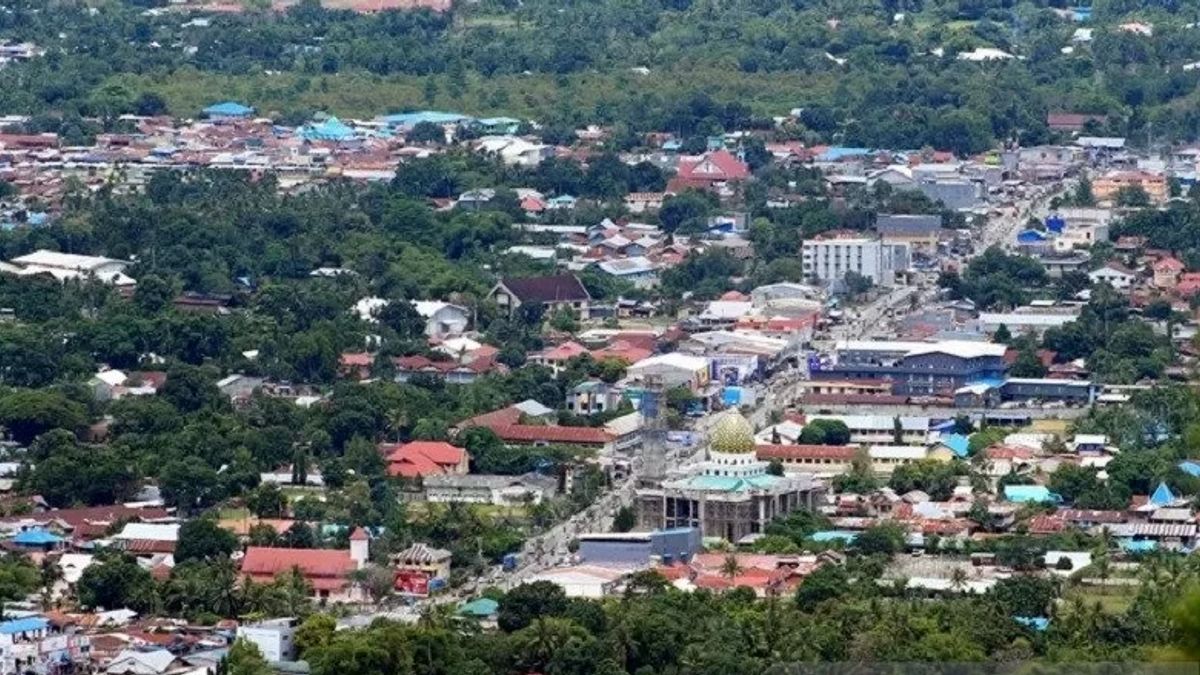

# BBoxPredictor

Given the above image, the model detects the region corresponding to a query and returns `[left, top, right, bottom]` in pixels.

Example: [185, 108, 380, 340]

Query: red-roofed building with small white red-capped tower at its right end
[241, 527, 370, 602]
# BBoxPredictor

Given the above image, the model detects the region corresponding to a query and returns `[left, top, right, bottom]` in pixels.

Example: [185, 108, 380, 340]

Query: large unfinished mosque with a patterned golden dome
[637, 411, 824, 542]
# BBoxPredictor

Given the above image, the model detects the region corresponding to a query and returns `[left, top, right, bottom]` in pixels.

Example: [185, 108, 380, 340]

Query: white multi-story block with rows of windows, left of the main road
[800, 233, 910, 287]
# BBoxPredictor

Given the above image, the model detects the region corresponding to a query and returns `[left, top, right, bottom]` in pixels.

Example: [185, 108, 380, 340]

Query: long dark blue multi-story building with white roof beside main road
[810, 340, 1006, 396]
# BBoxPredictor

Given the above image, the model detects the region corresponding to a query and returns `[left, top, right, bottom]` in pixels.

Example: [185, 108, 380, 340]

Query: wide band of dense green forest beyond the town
[7, 0, 1200, 151]
